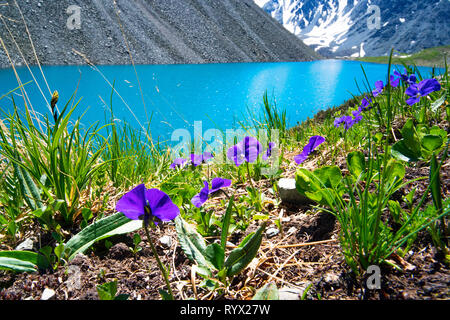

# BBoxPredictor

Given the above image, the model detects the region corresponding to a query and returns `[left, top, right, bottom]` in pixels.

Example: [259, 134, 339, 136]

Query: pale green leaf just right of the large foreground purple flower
[175, 216, 214, 269]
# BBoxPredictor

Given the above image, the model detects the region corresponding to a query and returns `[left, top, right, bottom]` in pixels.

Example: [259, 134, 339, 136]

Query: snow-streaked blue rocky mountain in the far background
[254, 0, 450, 57]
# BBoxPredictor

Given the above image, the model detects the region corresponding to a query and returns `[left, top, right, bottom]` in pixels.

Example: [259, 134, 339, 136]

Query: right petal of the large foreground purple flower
[145, 189, 180, 221]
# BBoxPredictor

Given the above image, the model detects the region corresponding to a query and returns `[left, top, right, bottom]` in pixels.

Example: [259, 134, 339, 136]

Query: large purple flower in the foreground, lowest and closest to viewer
[116, 184, 180, 226]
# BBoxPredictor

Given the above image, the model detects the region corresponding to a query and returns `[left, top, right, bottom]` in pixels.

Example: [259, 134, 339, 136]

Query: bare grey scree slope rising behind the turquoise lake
[0, 0, 319, 67]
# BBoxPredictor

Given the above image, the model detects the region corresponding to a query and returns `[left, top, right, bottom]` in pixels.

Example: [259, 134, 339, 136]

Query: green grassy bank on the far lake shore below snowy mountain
[352, 45, 450, 67]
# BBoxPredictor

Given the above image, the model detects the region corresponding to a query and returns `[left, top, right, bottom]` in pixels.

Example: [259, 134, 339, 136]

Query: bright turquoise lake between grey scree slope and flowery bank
[0, 60, 442, 141]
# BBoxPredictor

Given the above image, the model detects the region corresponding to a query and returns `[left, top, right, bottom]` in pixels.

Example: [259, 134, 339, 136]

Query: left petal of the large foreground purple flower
[116, 184, 146, 220]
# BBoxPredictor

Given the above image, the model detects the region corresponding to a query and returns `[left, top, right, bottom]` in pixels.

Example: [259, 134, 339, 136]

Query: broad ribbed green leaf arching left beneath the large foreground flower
[65, 212, 142, 260]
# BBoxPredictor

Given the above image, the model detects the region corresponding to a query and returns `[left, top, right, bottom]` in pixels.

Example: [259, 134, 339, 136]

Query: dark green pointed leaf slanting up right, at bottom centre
[224, 222, 267, 277]
